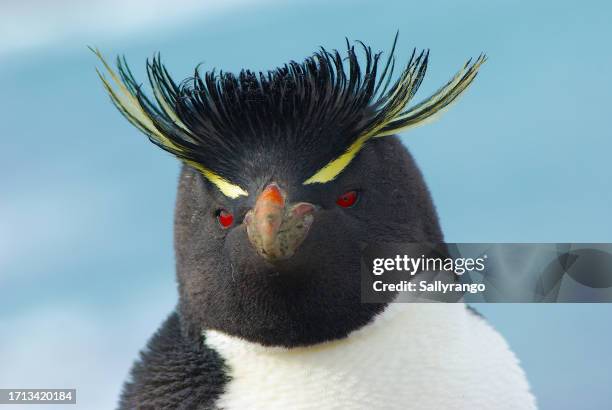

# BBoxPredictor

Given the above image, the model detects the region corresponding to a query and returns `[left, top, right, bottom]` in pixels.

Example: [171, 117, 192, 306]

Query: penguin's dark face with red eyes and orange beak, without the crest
[175, 138, 442, 347]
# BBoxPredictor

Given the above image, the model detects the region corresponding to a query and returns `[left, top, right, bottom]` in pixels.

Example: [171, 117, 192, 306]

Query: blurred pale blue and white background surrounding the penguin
[0, 0, 612, 409]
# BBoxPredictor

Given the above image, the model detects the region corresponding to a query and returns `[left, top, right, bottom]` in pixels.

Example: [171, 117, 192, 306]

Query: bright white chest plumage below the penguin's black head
[206, 303, 535, 410]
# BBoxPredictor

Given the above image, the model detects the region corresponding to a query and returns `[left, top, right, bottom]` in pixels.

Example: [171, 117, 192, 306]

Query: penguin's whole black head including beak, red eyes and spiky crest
[96, 38, 484, 347]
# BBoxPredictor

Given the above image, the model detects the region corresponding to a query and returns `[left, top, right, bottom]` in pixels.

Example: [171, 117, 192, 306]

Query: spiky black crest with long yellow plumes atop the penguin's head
[94, 36, 486, 198]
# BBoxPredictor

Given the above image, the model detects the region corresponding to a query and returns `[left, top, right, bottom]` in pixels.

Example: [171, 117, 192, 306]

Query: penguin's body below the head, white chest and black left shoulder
[120, 303, 536, 410]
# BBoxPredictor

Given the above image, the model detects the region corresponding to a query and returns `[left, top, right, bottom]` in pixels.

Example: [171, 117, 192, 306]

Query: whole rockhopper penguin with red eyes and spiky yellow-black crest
[94, 36, 535, 410]
